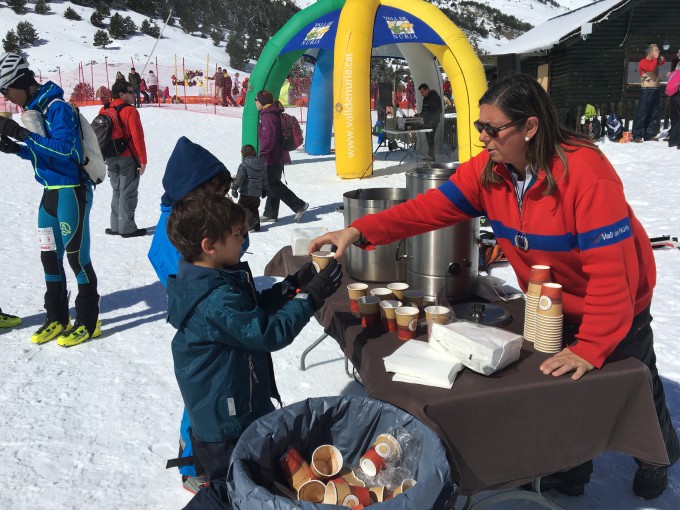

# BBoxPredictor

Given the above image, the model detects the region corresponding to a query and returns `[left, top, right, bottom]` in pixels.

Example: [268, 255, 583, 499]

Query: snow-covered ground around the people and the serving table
[0, 107, 680, 510]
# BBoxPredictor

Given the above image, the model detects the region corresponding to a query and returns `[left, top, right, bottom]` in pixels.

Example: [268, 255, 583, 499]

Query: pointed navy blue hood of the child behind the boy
[161, 136, 227, 206]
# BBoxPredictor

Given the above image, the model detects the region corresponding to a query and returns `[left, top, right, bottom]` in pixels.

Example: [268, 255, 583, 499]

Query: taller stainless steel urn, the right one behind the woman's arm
[406, 163, 479, 302]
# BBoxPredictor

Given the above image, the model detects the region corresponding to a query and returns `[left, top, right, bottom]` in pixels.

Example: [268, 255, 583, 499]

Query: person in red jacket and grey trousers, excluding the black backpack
[100, 80, 146, 238]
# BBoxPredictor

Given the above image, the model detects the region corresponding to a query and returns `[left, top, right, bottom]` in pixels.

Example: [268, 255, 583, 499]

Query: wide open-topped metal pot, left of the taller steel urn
[343, 188, 407, 282]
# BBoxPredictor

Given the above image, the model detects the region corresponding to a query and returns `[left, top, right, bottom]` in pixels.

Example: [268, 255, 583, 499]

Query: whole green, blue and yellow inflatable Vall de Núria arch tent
[242, 0, 486, 179]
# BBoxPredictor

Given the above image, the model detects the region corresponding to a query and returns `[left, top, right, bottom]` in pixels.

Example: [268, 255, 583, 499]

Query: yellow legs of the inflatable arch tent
[333, 0, 486, 179]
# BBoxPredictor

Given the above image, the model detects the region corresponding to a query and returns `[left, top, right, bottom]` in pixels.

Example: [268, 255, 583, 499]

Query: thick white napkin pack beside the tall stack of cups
[429, 321, 523, 375]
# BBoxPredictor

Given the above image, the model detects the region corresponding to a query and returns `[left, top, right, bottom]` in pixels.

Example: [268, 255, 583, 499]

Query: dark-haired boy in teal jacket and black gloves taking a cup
[167, 191, 342, 508]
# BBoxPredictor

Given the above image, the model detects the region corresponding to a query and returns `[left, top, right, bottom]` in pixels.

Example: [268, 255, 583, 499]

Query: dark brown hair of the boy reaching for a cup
[166, 190, 246, 263]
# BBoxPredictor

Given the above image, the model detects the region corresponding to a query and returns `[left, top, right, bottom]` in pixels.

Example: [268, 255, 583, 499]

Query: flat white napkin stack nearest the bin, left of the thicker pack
[383, 340, 463, 389]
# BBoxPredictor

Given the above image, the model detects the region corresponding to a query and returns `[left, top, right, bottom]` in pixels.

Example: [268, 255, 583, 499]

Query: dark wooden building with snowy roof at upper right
[496, 0, 680, 127]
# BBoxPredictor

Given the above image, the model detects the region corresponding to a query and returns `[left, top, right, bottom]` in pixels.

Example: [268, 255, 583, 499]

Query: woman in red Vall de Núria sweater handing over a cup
[310, 75, 680, 499]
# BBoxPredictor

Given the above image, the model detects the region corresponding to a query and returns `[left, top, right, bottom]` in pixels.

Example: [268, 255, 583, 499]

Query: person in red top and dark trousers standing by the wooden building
[633, 44, 666, 143]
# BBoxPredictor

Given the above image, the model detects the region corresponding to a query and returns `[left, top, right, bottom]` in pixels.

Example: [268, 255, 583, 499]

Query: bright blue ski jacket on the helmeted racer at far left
[19, 81, 83, 188]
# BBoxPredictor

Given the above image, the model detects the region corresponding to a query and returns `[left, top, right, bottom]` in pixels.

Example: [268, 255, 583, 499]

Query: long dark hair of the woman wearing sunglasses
[479, 74, 600, 195]
